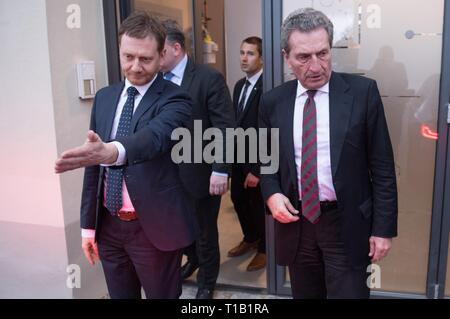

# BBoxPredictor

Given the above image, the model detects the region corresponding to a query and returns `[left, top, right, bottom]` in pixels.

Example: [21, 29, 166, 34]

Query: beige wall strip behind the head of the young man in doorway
[225, 0, 264, 92]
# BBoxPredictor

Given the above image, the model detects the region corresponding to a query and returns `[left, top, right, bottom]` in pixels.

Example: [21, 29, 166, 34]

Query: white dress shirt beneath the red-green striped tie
[294, 82, 336, 201]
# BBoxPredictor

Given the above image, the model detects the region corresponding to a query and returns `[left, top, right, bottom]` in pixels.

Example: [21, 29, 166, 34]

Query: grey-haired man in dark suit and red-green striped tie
[260, 8, 397, 298]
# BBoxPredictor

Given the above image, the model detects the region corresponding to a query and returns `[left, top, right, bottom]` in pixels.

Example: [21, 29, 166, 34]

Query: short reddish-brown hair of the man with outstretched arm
[119, 11, 166, 53]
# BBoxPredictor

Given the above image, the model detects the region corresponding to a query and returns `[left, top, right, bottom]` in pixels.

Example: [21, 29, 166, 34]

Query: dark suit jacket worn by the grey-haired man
[260, 72, 397, 266]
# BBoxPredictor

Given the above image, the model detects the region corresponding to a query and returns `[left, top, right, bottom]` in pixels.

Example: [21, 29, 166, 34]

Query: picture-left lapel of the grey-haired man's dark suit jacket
[279, 80, 298, 182]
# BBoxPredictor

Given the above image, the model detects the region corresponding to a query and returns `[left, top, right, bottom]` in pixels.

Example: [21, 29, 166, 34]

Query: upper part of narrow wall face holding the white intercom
[47, 0, 108, 225]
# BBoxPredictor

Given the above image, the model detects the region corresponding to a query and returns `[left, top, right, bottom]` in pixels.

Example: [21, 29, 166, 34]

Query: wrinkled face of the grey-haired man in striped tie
[283, 28, 331, 90]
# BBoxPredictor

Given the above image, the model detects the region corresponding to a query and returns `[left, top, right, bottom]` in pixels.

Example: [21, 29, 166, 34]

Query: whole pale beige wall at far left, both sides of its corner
[0, 0, 107, 298]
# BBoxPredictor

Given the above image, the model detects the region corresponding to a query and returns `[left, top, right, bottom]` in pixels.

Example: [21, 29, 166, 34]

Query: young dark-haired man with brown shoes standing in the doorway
[228, 37, 266, 271]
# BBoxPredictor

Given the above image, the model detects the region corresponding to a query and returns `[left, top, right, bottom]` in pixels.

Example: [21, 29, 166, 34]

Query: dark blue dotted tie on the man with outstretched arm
[106, 86, 139, 214]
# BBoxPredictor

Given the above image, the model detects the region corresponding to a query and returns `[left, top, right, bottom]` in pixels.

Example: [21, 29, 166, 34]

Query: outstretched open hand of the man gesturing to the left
[55, 131, 119, 174]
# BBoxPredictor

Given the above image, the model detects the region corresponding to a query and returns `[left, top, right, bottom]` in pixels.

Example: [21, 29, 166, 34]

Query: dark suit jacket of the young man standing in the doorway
[233, 74, 263, 176]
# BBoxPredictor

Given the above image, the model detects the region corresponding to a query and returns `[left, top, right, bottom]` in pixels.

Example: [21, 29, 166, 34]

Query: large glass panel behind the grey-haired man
[283, 0, 448, 293]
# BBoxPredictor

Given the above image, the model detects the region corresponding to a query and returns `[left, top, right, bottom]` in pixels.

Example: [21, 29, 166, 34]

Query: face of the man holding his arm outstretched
[119, 34, 161, 85]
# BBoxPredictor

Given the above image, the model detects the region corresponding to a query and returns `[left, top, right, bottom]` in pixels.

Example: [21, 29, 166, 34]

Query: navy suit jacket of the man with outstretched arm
[81, 75, 197, 251]
